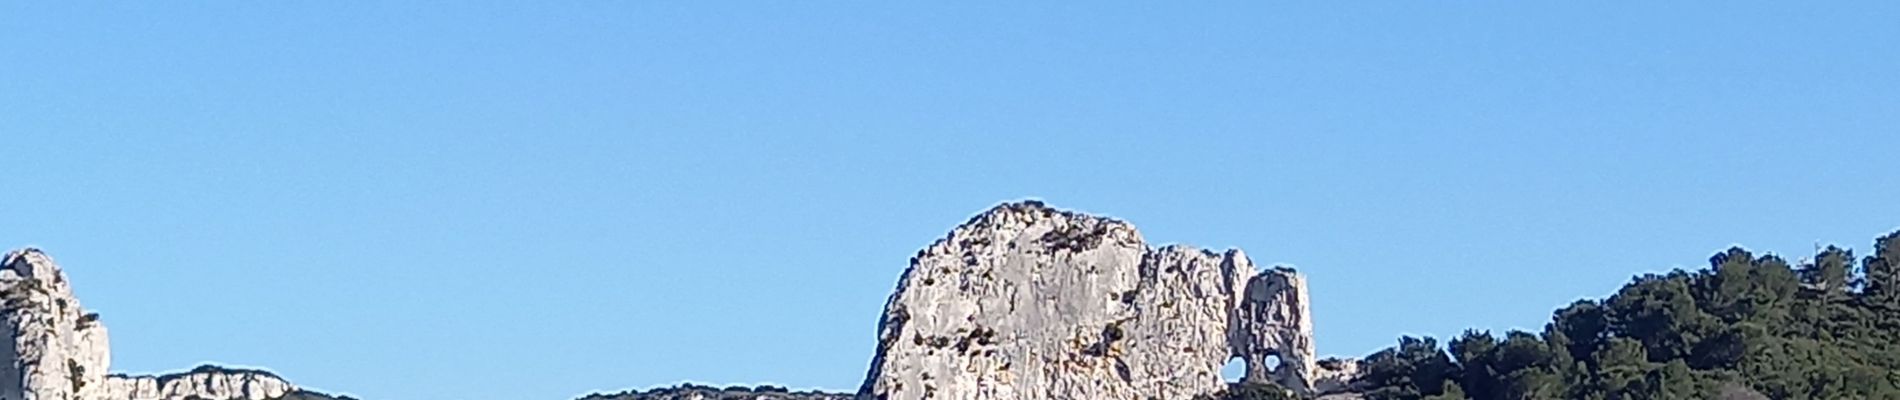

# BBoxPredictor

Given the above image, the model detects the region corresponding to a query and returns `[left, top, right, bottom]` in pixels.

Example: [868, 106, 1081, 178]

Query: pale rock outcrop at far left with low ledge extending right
[0, 248, 307, 400]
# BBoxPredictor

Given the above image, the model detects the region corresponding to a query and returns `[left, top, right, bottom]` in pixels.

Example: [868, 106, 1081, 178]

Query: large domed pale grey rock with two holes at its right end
[859, 201, 1315, 400]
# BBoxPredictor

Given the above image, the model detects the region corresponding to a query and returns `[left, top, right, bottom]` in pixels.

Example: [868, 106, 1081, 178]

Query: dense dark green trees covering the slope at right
[1360, 231, 1900, 400]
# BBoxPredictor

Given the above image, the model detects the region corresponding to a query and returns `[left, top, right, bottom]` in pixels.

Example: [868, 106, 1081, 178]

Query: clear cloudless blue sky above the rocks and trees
[0, 2, 1900, 400]
